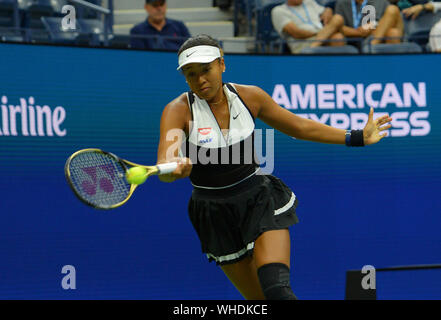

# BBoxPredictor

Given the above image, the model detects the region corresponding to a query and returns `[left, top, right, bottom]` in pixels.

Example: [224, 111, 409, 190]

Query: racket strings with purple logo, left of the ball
[69, 151, 130, 208]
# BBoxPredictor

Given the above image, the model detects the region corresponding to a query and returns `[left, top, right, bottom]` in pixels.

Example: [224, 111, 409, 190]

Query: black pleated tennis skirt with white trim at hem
[188, 174, 299, 265]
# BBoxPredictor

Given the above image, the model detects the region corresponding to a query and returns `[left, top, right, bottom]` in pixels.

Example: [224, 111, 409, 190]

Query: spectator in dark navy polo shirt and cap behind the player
[130, 0, 191, 51]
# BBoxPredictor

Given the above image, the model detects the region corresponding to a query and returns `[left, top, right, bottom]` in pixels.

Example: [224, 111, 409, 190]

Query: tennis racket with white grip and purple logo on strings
[64, 149, 178, 209]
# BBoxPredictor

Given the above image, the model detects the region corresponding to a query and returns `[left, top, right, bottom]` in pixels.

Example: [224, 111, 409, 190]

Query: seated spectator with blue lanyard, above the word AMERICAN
[335, 0, 404, 45]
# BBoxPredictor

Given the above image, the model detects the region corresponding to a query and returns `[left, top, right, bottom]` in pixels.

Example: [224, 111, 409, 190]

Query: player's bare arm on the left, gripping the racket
[157, 94, 192, 182]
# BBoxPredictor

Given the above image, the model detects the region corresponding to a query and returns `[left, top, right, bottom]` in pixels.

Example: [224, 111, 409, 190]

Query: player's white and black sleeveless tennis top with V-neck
[182, 83, 259, 189]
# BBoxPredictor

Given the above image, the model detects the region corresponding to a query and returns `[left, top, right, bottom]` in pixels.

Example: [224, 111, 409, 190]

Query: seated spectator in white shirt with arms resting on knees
[271, 0, 345, 53]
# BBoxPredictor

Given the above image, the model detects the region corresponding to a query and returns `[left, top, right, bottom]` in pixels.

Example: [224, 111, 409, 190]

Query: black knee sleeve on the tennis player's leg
[257, 263, 297, 300]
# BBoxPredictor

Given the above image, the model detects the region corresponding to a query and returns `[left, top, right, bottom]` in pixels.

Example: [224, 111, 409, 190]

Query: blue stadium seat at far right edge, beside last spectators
[403, 12, 441, 46]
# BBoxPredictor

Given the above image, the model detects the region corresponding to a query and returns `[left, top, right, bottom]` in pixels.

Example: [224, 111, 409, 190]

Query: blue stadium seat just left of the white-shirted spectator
[256, 0, 286, 52]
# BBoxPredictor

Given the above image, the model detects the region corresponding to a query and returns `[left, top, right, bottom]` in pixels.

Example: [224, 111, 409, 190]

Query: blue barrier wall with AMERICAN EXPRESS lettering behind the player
[0, 44, 441, 299]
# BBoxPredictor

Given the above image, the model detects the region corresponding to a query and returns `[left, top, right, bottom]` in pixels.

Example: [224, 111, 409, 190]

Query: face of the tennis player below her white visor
[182, 58, 225, 100]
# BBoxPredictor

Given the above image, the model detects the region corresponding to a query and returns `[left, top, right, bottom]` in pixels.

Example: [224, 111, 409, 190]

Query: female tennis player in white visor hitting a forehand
[158, 35, 392, 300]
